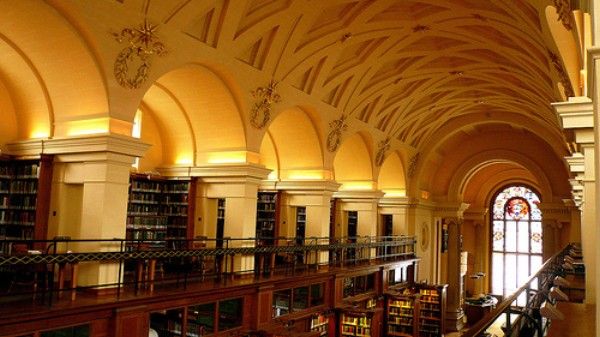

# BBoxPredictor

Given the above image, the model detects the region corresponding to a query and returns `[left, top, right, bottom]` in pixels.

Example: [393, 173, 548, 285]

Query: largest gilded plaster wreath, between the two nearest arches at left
[113, 20, 167, 89]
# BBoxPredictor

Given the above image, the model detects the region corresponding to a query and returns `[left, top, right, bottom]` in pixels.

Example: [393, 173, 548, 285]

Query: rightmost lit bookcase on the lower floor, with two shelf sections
[386, 284, 447, 337]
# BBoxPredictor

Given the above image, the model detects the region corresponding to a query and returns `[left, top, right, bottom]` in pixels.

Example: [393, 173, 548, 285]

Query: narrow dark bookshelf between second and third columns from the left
[256, 192, 278, 245]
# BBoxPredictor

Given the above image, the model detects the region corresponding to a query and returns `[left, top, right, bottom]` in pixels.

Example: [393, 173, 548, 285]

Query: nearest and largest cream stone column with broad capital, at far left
[9, 135, 149, 288]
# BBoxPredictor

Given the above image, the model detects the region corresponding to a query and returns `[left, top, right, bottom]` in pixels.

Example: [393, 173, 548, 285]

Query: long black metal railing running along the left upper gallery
[0, 236, 416, 305]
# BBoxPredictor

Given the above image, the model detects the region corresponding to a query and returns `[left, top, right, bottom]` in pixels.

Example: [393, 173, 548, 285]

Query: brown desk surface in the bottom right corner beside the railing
[546, 302, 596, 337]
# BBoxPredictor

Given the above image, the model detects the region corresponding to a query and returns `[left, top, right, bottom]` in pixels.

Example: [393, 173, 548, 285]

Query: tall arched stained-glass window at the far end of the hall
[491, 186, 542, 305]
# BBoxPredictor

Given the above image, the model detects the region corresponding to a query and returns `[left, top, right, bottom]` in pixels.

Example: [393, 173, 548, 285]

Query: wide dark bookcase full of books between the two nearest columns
[126, 175, 195, 249]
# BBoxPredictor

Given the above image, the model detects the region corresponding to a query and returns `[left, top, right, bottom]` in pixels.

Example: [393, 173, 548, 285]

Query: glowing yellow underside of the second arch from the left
[143, 64, 246, 165]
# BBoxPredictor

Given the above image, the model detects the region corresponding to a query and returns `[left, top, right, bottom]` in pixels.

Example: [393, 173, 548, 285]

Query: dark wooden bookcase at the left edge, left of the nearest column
[0, 155, 54, 253]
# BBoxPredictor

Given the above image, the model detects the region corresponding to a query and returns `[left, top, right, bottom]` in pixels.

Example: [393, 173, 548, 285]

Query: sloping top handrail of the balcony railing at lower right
[462, 244, 573, 337]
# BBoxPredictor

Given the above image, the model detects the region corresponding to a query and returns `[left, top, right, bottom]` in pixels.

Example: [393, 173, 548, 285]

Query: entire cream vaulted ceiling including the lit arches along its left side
[0, 0, 586, 200]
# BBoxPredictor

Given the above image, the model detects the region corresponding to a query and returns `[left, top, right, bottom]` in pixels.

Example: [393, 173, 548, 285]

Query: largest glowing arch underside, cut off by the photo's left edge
[0, 1, 109, 139]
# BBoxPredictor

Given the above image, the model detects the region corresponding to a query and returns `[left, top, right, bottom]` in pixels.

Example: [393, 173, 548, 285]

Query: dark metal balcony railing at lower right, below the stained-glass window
[462, 243, 584, 337]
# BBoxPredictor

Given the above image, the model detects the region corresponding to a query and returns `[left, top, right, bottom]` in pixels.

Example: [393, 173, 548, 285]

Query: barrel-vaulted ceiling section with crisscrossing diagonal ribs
[141, 0, 572, 149]
